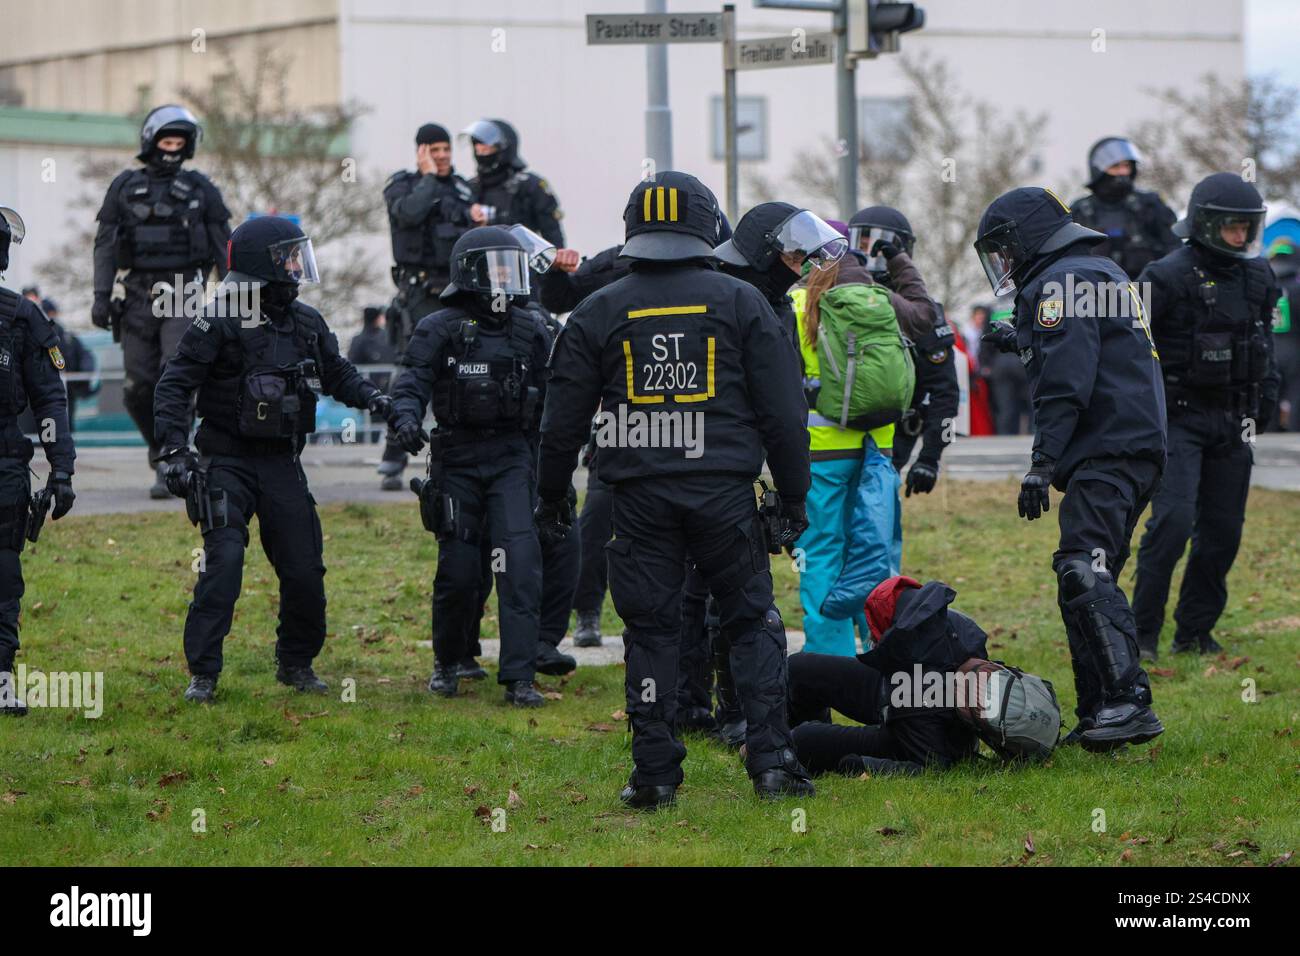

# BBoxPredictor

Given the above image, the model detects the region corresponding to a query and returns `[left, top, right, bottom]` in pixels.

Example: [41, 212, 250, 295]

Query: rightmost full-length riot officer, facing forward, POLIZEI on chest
[1134, 173, 1279, 658]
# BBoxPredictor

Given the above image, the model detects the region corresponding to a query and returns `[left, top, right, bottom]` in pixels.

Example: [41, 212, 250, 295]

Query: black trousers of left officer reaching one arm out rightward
[185, 450, 325, 676]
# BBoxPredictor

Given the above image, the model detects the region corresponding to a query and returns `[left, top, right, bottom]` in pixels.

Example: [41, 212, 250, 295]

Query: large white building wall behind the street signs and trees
[339, 0, 1244, 252]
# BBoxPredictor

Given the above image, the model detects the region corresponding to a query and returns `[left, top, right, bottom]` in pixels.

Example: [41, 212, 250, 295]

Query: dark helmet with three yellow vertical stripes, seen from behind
[621, 172, 722, 261]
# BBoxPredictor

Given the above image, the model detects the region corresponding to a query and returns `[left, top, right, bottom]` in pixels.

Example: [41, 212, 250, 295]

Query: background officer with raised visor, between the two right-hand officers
[1070, 137, 1178, 278]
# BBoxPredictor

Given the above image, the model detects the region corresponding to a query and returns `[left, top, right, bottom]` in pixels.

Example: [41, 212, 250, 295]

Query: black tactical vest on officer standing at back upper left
[116, 169, 211, 272]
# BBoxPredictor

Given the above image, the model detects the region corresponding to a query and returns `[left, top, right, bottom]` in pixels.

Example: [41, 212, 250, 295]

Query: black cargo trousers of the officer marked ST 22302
[606, 475, 798, 786]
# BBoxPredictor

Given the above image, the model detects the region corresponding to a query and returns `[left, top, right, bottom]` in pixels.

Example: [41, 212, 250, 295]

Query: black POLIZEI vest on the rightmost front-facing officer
[1154, 263, 1271, 401]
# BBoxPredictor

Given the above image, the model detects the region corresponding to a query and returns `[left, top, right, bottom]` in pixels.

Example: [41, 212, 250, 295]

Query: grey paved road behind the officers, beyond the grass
[55, 433, 1300, 515]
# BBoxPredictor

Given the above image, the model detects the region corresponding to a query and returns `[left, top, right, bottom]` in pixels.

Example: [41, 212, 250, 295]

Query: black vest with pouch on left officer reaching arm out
[198, 307, 321, 441]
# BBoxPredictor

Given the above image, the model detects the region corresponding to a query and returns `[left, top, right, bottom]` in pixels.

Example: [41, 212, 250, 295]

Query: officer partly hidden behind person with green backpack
[849, 206, 961, 498]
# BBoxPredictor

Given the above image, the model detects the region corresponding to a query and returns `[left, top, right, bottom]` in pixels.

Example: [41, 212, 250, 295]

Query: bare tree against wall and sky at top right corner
[1132, 74, 1300, 204]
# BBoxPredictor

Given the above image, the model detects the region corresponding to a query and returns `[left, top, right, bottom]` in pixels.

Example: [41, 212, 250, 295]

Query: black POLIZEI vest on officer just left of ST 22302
[433, 311, 538, 433]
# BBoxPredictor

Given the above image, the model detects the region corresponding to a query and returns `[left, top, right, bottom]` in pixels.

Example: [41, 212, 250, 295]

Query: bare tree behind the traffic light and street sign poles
[750, 56, 1047, 306]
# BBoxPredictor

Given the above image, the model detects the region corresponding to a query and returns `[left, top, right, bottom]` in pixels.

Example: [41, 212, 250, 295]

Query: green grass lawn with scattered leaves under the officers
[0, 480, 1300, 866]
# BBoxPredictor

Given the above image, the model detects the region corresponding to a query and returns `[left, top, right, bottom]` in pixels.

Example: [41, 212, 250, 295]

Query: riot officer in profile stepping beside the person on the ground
[975, 187, 1165, 750]
